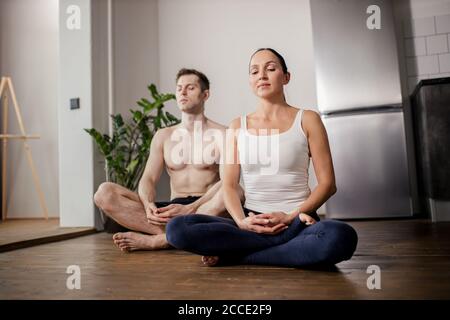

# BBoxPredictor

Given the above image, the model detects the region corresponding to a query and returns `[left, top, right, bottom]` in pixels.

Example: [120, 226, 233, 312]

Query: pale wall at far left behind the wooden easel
[0, 0, 59, 218]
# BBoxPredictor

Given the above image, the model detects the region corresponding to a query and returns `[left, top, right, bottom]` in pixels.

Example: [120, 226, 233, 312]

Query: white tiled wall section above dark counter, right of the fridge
[403, 14, 450, 93]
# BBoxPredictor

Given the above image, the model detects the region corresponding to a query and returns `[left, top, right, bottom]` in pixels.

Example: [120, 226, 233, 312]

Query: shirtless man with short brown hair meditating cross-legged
[94, 69, 237, 251]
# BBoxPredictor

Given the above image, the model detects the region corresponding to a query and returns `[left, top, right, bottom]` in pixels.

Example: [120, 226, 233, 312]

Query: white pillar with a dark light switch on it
[58, 0, 94, 227]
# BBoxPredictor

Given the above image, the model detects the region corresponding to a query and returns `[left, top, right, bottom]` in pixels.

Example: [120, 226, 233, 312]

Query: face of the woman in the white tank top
[249, 50, 289, 98]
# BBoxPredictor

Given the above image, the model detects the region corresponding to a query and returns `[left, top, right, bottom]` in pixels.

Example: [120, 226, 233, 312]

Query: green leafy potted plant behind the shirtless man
[84, 84, 180, 232]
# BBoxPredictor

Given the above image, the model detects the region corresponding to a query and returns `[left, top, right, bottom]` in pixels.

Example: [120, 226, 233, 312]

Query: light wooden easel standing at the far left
[0, 77, 48, 220]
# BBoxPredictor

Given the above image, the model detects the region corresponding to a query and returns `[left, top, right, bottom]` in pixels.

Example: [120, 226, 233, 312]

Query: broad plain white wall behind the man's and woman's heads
[159, 0, 316, 125]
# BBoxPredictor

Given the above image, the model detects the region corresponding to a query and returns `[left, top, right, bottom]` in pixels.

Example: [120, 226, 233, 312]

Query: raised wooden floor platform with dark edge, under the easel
[0, 218, 95, 252]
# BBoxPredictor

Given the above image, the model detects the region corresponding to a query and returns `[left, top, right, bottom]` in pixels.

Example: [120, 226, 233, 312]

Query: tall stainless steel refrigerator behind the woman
[311, 0, 413, 219]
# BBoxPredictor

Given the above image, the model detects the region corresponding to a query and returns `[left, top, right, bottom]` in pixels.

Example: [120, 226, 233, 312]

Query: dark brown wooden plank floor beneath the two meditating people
[0, 220, 450, 300]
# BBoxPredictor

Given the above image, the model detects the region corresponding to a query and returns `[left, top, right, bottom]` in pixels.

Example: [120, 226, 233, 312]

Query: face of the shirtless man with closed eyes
[176, 74, 209, 113]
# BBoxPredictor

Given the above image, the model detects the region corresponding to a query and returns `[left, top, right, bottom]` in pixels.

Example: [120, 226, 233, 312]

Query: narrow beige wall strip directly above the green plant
[113, 0, 174, 201]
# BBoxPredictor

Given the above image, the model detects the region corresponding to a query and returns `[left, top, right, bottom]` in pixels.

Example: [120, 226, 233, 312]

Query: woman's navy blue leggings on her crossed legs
[166, 214, 358, 267]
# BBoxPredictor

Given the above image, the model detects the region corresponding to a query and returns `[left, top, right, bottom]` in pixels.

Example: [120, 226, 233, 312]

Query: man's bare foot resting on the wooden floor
[113, 231, 169, 252]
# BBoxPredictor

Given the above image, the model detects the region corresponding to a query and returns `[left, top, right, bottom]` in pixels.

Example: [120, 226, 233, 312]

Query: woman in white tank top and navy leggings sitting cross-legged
[167, 48, 358, 267]
